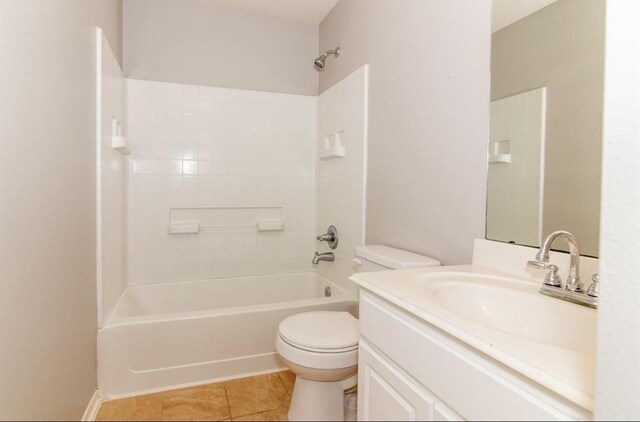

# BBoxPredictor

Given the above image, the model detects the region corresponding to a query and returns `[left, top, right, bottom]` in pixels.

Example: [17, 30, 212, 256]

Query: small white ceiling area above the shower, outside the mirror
[201, 0, 338, 25]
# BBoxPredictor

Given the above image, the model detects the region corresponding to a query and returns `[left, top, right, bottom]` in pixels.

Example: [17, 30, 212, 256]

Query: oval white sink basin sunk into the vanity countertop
[414, 272, 596, 353]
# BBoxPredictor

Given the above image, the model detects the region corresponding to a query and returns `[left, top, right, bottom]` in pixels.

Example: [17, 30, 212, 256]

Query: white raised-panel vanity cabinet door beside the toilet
[358, 341, 433, 421]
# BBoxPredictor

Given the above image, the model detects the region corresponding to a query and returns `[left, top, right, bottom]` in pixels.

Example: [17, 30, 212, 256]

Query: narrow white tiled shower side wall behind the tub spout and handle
[316, 66, 368, 297]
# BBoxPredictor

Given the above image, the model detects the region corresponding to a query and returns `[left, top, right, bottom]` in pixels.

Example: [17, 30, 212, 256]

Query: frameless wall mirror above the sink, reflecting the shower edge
[486, 0, 605, 256]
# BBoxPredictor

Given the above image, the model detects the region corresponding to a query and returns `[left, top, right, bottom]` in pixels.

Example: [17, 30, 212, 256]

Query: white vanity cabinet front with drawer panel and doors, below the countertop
[358, 290, 591, 421]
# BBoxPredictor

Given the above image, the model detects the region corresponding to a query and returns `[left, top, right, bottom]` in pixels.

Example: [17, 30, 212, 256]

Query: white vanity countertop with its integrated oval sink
[351, 265, 596, 411]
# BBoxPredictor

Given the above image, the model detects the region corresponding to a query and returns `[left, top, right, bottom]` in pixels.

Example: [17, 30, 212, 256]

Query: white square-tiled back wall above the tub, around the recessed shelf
[128, 79, 317, 284]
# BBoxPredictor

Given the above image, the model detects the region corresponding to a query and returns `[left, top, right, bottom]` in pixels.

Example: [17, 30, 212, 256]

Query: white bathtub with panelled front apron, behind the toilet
[98, 272, 357, 400]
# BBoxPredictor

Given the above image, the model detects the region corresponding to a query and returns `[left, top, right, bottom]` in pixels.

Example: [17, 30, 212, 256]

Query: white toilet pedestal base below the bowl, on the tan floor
[289, 376, 357, 421]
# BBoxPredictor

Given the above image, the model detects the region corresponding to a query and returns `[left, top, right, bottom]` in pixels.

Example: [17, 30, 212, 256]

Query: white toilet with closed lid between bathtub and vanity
[276, 245, 440, 421]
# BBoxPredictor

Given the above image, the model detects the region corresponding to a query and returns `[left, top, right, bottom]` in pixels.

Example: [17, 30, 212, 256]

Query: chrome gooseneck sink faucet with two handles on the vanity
[527, 231, 598, 308]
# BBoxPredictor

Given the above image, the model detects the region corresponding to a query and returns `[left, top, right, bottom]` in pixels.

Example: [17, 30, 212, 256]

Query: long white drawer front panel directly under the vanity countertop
[360, 291, 588, 420]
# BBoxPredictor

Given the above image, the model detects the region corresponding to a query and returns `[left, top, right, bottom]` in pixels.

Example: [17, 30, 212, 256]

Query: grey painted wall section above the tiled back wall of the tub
[124, 0, 318, 95]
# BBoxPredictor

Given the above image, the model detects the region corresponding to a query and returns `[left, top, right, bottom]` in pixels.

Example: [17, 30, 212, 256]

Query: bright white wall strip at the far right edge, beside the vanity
[595, 0, 640, 420]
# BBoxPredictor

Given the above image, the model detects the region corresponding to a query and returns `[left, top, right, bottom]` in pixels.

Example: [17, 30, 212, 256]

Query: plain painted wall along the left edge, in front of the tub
[0, 0, 96, 420]
